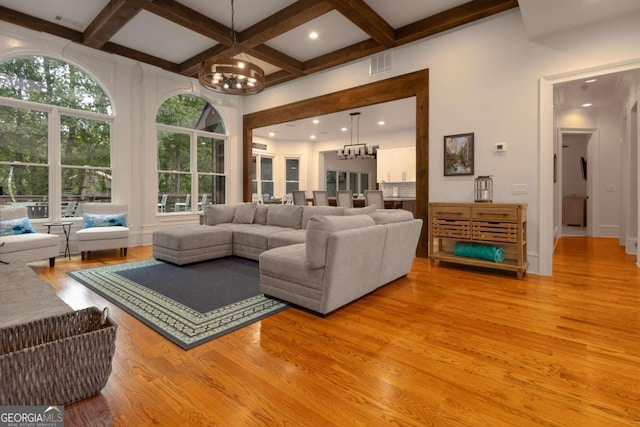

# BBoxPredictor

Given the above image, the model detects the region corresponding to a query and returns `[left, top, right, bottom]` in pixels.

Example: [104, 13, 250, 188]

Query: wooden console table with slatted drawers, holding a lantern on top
[429, 203, 529, 279]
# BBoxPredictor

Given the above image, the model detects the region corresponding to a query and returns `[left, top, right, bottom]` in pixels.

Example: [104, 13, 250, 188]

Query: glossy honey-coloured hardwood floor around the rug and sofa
[32, 238, 640, 427]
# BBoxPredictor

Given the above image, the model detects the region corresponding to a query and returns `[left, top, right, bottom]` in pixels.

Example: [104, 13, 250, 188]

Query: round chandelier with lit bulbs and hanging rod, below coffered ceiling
[198, 0, 265, 95]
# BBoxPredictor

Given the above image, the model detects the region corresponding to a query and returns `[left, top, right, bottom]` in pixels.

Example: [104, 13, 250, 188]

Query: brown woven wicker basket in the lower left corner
[0, 307, 117, 405]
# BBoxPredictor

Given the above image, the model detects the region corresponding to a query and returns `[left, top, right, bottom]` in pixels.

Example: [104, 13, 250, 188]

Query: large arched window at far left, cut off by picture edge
[0, 56, 113, 219]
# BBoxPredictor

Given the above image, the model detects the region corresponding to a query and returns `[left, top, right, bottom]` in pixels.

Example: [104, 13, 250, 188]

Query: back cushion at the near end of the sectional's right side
[305, 215, 375, 268]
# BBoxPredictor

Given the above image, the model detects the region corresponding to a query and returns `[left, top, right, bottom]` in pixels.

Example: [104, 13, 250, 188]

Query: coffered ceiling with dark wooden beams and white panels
[0, 0, 518, 86]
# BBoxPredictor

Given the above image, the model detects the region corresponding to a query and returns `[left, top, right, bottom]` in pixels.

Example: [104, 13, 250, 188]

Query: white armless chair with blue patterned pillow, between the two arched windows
[76, 203, 129, 259]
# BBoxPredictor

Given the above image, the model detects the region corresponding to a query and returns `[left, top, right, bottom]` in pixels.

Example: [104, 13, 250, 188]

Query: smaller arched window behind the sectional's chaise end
[156, 95, 227, 213]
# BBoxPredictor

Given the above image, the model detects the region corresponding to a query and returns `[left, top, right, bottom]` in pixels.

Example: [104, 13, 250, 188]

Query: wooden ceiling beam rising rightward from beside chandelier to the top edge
[239, 0, 334, 48]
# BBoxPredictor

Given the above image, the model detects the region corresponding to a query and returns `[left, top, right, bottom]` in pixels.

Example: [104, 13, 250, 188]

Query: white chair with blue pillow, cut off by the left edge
[0, 206, 60, 267]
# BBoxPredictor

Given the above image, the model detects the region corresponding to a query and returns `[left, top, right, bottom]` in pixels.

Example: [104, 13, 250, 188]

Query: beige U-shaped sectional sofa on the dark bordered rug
[153, 203, 422, 314]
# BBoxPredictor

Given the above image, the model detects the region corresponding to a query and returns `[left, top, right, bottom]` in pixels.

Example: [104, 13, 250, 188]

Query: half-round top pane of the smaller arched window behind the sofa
[156, 95, 225, 134]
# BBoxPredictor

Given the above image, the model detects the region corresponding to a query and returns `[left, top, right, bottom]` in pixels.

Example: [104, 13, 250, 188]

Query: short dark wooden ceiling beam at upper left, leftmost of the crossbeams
[83, 0, 142, 49]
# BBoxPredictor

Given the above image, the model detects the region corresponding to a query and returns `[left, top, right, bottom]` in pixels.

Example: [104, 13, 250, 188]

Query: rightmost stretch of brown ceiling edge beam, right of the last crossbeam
[396, 0, 518, 45]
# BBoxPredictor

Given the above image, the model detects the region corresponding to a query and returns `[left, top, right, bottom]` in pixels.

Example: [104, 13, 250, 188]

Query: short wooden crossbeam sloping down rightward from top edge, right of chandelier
[330, 0, 395, 48]
